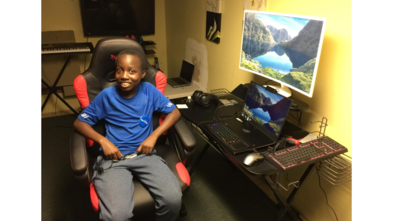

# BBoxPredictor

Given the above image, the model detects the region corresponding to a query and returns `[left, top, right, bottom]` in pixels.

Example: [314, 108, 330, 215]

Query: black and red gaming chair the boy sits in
[70, 38, 195, 220]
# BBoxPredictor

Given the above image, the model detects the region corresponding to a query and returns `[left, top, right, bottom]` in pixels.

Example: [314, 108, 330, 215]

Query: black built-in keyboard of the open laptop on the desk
[206, 122, 250, 150]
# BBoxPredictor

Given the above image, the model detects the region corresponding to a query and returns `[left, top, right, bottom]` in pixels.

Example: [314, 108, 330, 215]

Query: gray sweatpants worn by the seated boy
[93, 151, 182, 221]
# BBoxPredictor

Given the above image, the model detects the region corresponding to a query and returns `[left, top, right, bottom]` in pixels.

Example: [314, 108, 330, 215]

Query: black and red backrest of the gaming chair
[74, 38, 167, 155]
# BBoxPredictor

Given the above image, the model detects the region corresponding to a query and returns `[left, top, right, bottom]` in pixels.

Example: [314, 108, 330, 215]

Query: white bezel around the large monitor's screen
[239, 10, 326, 98]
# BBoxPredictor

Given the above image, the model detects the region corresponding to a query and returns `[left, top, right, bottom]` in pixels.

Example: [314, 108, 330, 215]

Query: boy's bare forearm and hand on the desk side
[137, 108, 181, 154]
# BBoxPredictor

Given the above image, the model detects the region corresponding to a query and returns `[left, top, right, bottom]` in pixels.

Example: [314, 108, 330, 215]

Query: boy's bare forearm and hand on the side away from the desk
[74, 118, 123, 160]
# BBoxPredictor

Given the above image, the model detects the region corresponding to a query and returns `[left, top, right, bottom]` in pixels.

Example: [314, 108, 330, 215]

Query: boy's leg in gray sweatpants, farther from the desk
[93, 156, 134, 221]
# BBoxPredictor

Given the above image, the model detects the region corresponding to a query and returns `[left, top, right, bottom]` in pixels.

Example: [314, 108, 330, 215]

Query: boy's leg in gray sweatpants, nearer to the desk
[129, 154, 182, 221]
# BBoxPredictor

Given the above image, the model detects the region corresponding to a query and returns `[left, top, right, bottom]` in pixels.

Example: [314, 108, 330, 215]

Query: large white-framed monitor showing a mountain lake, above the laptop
[239, 10, 326, 97]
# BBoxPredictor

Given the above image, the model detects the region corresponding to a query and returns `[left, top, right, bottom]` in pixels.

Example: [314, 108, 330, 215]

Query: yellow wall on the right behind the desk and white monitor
[165, 0, 352, 221]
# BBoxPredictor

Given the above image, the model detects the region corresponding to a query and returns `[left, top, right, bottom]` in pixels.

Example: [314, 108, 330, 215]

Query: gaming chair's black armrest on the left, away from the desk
[70, 131, 89, 176]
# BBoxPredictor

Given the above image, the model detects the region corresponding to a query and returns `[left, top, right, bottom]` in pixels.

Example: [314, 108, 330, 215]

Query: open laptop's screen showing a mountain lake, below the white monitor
[242, 81, 292, 137]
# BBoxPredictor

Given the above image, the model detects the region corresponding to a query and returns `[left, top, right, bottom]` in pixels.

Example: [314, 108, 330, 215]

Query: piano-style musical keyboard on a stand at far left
[41, 42, 94, 54]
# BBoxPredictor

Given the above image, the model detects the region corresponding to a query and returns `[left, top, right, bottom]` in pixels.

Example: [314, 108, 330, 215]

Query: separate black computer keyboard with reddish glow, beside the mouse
[265, 136, 348, 170]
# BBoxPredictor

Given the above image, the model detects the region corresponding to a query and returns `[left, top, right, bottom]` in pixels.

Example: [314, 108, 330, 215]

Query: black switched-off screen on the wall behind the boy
[80, 0, 155, 36]
